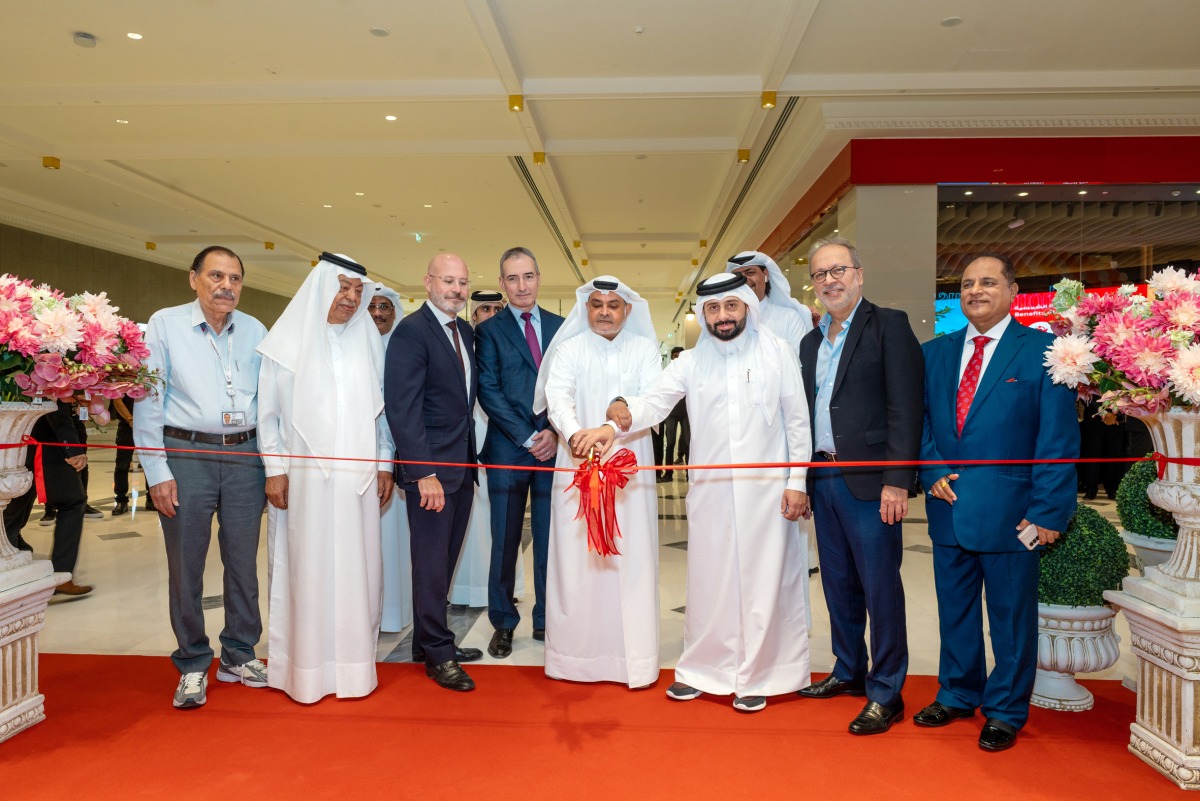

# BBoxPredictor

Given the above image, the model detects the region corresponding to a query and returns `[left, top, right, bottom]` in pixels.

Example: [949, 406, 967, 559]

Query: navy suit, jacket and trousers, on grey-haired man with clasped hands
[475, 307, 563, 628]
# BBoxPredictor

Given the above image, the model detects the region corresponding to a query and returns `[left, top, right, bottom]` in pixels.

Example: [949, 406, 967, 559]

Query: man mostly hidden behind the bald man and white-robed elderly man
[367, 284, 413, 632]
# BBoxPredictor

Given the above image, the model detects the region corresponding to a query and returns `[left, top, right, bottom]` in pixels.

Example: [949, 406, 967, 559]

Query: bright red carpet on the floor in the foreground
[0, 655, 1182, 801]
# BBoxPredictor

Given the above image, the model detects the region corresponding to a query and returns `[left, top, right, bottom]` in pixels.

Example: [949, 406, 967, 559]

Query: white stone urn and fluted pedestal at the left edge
[0, 403, 70, 742]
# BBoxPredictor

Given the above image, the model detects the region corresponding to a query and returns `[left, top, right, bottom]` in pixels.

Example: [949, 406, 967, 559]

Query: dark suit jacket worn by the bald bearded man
[383, 305, 479, 493]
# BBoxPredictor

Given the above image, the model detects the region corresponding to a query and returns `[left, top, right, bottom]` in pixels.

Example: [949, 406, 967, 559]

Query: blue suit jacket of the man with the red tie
[920, 319, 1079, 553]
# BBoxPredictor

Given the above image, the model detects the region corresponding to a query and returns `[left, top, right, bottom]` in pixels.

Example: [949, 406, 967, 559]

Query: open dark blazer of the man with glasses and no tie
[800, 297, 925, 500]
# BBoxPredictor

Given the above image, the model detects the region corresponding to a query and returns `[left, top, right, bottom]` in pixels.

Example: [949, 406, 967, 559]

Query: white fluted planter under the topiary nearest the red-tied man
[1030, 603, 1121, 712]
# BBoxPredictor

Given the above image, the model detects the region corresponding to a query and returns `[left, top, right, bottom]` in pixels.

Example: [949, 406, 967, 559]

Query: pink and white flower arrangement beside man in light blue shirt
[0, 275, 160, 424]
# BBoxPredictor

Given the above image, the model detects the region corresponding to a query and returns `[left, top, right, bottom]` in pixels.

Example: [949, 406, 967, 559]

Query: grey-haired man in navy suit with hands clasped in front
[475, 247, 563, 660]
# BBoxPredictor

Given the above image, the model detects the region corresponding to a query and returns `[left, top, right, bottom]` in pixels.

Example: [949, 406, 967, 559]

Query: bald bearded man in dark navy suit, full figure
[384, 253, 484, 691]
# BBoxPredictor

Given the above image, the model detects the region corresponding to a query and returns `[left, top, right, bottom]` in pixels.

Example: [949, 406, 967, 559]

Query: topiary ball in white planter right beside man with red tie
[1032, 505, 1129, 712]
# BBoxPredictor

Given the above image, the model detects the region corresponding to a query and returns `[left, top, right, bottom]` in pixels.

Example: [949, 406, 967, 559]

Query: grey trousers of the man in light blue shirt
[158, 436, 266, 673]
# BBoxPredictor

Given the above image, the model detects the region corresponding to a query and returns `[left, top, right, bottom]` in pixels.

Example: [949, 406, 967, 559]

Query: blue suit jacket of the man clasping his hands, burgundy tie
[475, 307, 563, 464]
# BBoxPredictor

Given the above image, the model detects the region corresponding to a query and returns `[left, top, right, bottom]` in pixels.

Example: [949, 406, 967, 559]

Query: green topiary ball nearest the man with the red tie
[1038, 504, 1129, 607]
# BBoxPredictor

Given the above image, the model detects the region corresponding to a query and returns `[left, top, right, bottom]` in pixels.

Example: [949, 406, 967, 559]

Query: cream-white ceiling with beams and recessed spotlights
[0, 0, 1200, 337]
